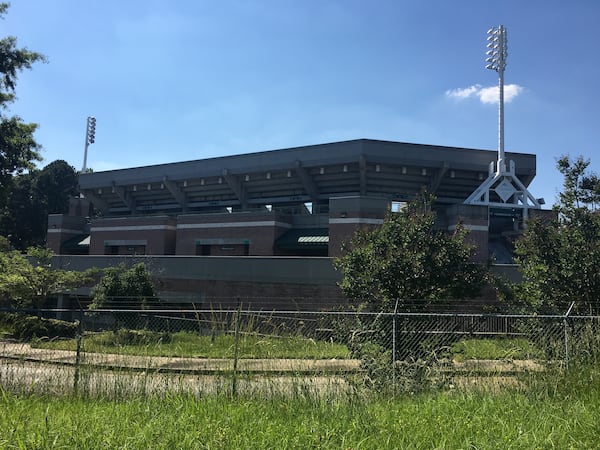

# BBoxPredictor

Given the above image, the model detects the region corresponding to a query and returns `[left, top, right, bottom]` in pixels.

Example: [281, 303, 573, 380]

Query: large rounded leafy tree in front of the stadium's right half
[334, 194, 486, 311]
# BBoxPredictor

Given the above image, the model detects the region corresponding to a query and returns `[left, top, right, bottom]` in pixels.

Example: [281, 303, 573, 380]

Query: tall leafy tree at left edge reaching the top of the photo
[0, 3, 45, 208]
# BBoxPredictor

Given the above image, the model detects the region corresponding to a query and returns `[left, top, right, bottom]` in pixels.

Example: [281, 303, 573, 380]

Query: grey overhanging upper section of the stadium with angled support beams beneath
[79, 139, 536, 215]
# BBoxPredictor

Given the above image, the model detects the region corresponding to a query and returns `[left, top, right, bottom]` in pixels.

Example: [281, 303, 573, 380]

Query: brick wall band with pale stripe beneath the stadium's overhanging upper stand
[48, 196, 496, 262]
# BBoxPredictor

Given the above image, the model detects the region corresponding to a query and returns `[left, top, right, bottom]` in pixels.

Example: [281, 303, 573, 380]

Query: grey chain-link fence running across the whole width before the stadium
[0, 307, 600, 395]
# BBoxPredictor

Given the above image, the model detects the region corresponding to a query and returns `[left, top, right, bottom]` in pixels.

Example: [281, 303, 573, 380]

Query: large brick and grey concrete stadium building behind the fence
[48, 139, 539, 310]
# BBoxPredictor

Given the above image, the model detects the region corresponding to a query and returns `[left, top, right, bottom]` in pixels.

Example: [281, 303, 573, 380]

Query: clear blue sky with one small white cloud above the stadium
[0, 0, 600, 205]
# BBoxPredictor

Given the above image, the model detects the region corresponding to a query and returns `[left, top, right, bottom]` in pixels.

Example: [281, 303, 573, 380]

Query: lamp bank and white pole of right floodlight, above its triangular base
[485, 25, 508, 173]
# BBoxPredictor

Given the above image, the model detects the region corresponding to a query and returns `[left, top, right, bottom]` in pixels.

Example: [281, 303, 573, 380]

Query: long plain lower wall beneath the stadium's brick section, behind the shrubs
[53, 256, 521, 310]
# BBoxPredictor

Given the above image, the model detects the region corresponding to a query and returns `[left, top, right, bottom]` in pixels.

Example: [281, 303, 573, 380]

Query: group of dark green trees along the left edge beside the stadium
[0, 3, 77, 251]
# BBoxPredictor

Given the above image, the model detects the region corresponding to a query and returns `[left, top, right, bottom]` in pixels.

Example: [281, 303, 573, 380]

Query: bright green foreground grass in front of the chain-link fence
[0, 371, 600, 449]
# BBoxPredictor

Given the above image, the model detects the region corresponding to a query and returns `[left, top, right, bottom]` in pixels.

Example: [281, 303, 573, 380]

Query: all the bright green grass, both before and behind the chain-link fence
[0, 331, 600, 449]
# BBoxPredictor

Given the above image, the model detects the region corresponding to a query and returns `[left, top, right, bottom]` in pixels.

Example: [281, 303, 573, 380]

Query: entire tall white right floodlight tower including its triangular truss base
[464, 25, 540, 219]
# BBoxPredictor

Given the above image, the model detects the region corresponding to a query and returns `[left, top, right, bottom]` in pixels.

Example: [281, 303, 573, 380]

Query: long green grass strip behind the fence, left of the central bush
[33, 331, 349, 359]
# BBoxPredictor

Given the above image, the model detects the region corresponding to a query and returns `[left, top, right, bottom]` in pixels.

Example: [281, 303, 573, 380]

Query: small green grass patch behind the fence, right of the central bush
[450, 338, 544, 361]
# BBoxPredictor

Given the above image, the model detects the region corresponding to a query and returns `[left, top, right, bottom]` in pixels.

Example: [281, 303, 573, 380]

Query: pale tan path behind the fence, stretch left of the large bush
[0, 341, 360, 398]
